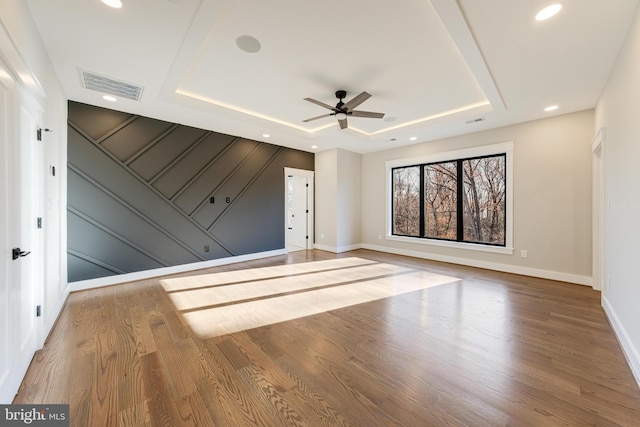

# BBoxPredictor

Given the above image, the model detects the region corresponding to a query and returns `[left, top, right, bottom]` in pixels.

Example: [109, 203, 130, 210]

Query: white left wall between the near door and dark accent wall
[0, 0, 67, 341]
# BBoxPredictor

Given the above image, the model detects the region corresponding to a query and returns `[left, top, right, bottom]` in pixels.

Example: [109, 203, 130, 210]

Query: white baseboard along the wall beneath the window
[361, 244, 592, 286]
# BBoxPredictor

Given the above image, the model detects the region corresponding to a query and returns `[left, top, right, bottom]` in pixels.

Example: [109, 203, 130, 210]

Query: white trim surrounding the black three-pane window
[385, 141, 513, 255]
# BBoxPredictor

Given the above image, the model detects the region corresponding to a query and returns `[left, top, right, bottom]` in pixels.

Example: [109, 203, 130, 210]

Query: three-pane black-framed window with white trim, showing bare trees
[387, 143, 513, 252]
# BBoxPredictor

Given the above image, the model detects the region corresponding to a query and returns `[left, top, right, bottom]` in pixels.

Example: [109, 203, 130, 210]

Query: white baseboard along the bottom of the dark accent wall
[69, 249, 287, 292]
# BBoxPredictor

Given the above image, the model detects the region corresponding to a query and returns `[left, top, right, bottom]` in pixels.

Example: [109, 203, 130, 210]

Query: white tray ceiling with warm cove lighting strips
[28, 0, 639, 153]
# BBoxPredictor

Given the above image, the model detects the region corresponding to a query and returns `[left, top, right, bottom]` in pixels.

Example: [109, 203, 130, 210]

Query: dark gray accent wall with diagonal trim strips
[67, 102, 314, 282]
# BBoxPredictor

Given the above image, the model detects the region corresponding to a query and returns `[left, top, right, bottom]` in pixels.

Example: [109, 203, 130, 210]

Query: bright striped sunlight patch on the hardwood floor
[162, 258, 459, 338]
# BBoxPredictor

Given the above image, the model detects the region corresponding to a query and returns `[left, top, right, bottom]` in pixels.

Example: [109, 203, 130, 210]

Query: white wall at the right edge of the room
[595, 2, 640, 383]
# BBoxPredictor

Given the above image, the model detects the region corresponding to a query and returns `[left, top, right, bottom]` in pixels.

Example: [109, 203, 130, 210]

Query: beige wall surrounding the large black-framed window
[362, 110, 594, 285]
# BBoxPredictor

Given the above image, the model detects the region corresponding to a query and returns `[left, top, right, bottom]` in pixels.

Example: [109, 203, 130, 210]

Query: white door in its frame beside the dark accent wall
[284, 168, 314, 252]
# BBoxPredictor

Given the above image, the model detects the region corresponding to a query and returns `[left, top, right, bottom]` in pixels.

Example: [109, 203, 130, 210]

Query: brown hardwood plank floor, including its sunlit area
[14, 250, 640, 427]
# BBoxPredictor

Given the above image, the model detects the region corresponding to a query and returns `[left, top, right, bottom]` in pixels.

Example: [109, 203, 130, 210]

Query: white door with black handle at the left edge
[0, 57, 44, 404]
